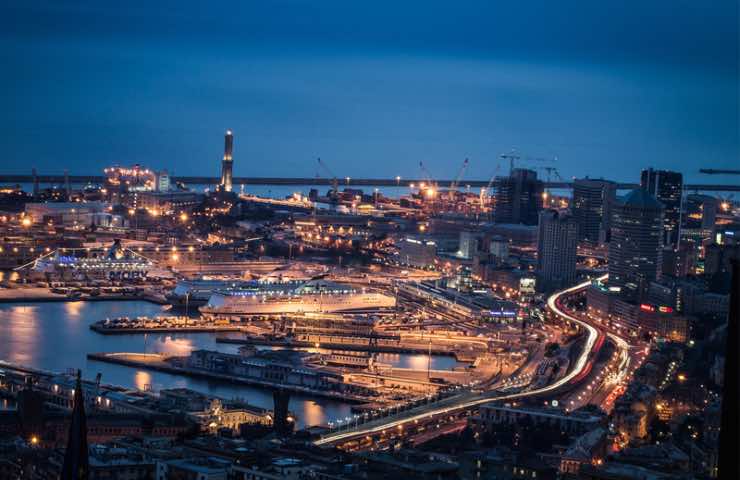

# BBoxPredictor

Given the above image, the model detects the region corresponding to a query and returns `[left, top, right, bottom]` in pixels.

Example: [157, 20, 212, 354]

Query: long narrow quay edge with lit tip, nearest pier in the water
[87, 352, 372, 403]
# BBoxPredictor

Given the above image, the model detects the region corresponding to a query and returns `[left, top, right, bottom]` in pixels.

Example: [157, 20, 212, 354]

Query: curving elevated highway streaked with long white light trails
[314, 275, 608, 446]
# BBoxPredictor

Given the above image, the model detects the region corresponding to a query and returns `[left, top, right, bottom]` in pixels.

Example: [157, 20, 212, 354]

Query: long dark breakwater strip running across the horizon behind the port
[0, 174, 740, 192]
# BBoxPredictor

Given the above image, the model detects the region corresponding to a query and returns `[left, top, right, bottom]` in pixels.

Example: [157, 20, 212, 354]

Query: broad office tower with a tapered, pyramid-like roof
[609, 188, 663, 299]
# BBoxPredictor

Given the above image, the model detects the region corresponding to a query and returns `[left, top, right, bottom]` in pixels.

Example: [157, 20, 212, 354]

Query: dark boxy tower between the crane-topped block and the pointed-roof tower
[572, 178, 617, 243]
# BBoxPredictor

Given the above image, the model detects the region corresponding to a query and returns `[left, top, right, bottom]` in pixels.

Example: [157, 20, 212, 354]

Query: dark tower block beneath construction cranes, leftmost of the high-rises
[493, 168, 545, 225]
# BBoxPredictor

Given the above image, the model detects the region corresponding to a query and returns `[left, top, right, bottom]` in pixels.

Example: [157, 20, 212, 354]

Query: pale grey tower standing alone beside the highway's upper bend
[537, 210, 578, 291]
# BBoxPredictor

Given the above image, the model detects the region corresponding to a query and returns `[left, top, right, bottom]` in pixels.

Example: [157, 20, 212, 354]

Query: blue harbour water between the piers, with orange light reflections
[0, 301, 457, 425]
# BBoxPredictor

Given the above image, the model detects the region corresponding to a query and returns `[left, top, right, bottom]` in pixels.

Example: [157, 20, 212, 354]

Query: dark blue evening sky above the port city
[0, 0, 740, 184]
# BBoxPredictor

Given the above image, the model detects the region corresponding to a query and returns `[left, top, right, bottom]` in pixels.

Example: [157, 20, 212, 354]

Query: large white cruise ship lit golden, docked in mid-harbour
[200, 280, 396, 316]
